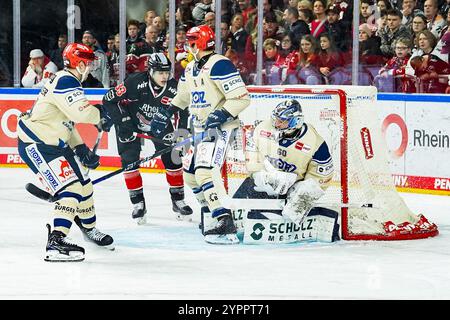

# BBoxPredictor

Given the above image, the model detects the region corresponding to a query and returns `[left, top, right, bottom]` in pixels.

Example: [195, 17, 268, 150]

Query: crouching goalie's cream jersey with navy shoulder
[246, 119, 334, 189]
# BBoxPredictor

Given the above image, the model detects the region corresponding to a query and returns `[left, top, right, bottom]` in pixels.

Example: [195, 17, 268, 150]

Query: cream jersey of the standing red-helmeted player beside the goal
[172, 54, 250, 127]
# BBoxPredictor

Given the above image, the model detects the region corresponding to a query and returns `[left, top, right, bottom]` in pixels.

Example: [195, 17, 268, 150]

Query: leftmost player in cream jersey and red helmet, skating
[17, 43, 113, 262]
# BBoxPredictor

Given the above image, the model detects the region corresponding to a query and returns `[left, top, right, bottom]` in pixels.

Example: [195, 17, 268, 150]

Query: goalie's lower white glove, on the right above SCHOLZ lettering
[282, 179, 325, 226]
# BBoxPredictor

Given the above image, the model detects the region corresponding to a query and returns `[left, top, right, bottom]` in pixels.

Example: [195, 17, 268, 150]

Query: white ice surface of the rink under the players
[0, 168, 450, 300]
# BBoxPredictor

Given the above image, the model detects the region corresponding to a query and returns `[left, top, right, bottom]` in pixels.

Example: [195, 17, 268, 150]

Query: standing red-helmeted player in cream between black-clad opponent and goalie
[151, 25, 250, 244]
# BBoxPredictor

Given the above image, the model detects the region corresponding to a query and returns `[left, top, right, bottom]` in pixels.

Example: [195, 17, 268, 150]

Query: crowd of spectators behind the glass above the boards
[22, 0, 450, 93]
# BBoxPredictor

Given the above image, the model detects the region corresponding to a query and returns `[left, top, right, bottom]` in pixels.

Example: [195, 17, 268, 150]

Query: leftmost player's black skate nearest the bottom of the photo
[44, 224, 84, 262]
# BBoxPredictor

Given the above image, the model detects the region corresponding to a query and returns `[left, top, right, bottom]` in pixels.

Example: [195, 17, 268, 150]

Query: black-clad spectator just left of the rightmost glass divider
[325, 5, 352, 52]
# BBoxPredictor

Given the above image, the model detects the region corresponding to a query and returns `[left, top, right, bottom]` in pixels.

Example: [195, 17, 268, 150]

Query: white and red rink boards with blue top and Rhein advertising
[0, 88, 450, 195]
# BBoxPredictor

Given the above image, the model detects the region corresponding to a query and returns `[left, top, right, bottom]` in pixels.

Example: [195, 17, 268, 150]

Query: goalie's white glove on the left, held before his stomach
[253, 159, 297, 196]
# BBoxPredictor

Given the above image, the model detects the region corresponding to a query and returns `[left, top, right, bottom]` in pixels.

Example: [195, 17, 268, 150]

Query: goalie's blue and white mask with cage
[272, 100, 304, 138]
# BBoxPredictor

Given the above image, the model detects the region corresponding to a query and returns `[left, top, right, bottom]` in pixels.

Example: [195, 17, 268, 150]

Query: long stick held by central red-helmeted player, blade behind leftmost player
[25, 132, 207, 202]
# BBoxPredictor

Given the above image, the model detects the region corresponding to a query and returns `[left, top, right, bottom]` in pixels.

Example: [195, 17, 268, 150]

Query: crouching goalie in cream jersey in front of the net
[236, 100, 339, 241]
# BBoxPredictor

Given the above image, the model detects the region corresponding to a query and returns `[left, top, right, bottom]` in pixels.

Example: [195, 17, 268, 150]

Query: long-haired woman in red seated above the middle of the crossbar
[297, 34, 323, 85]
